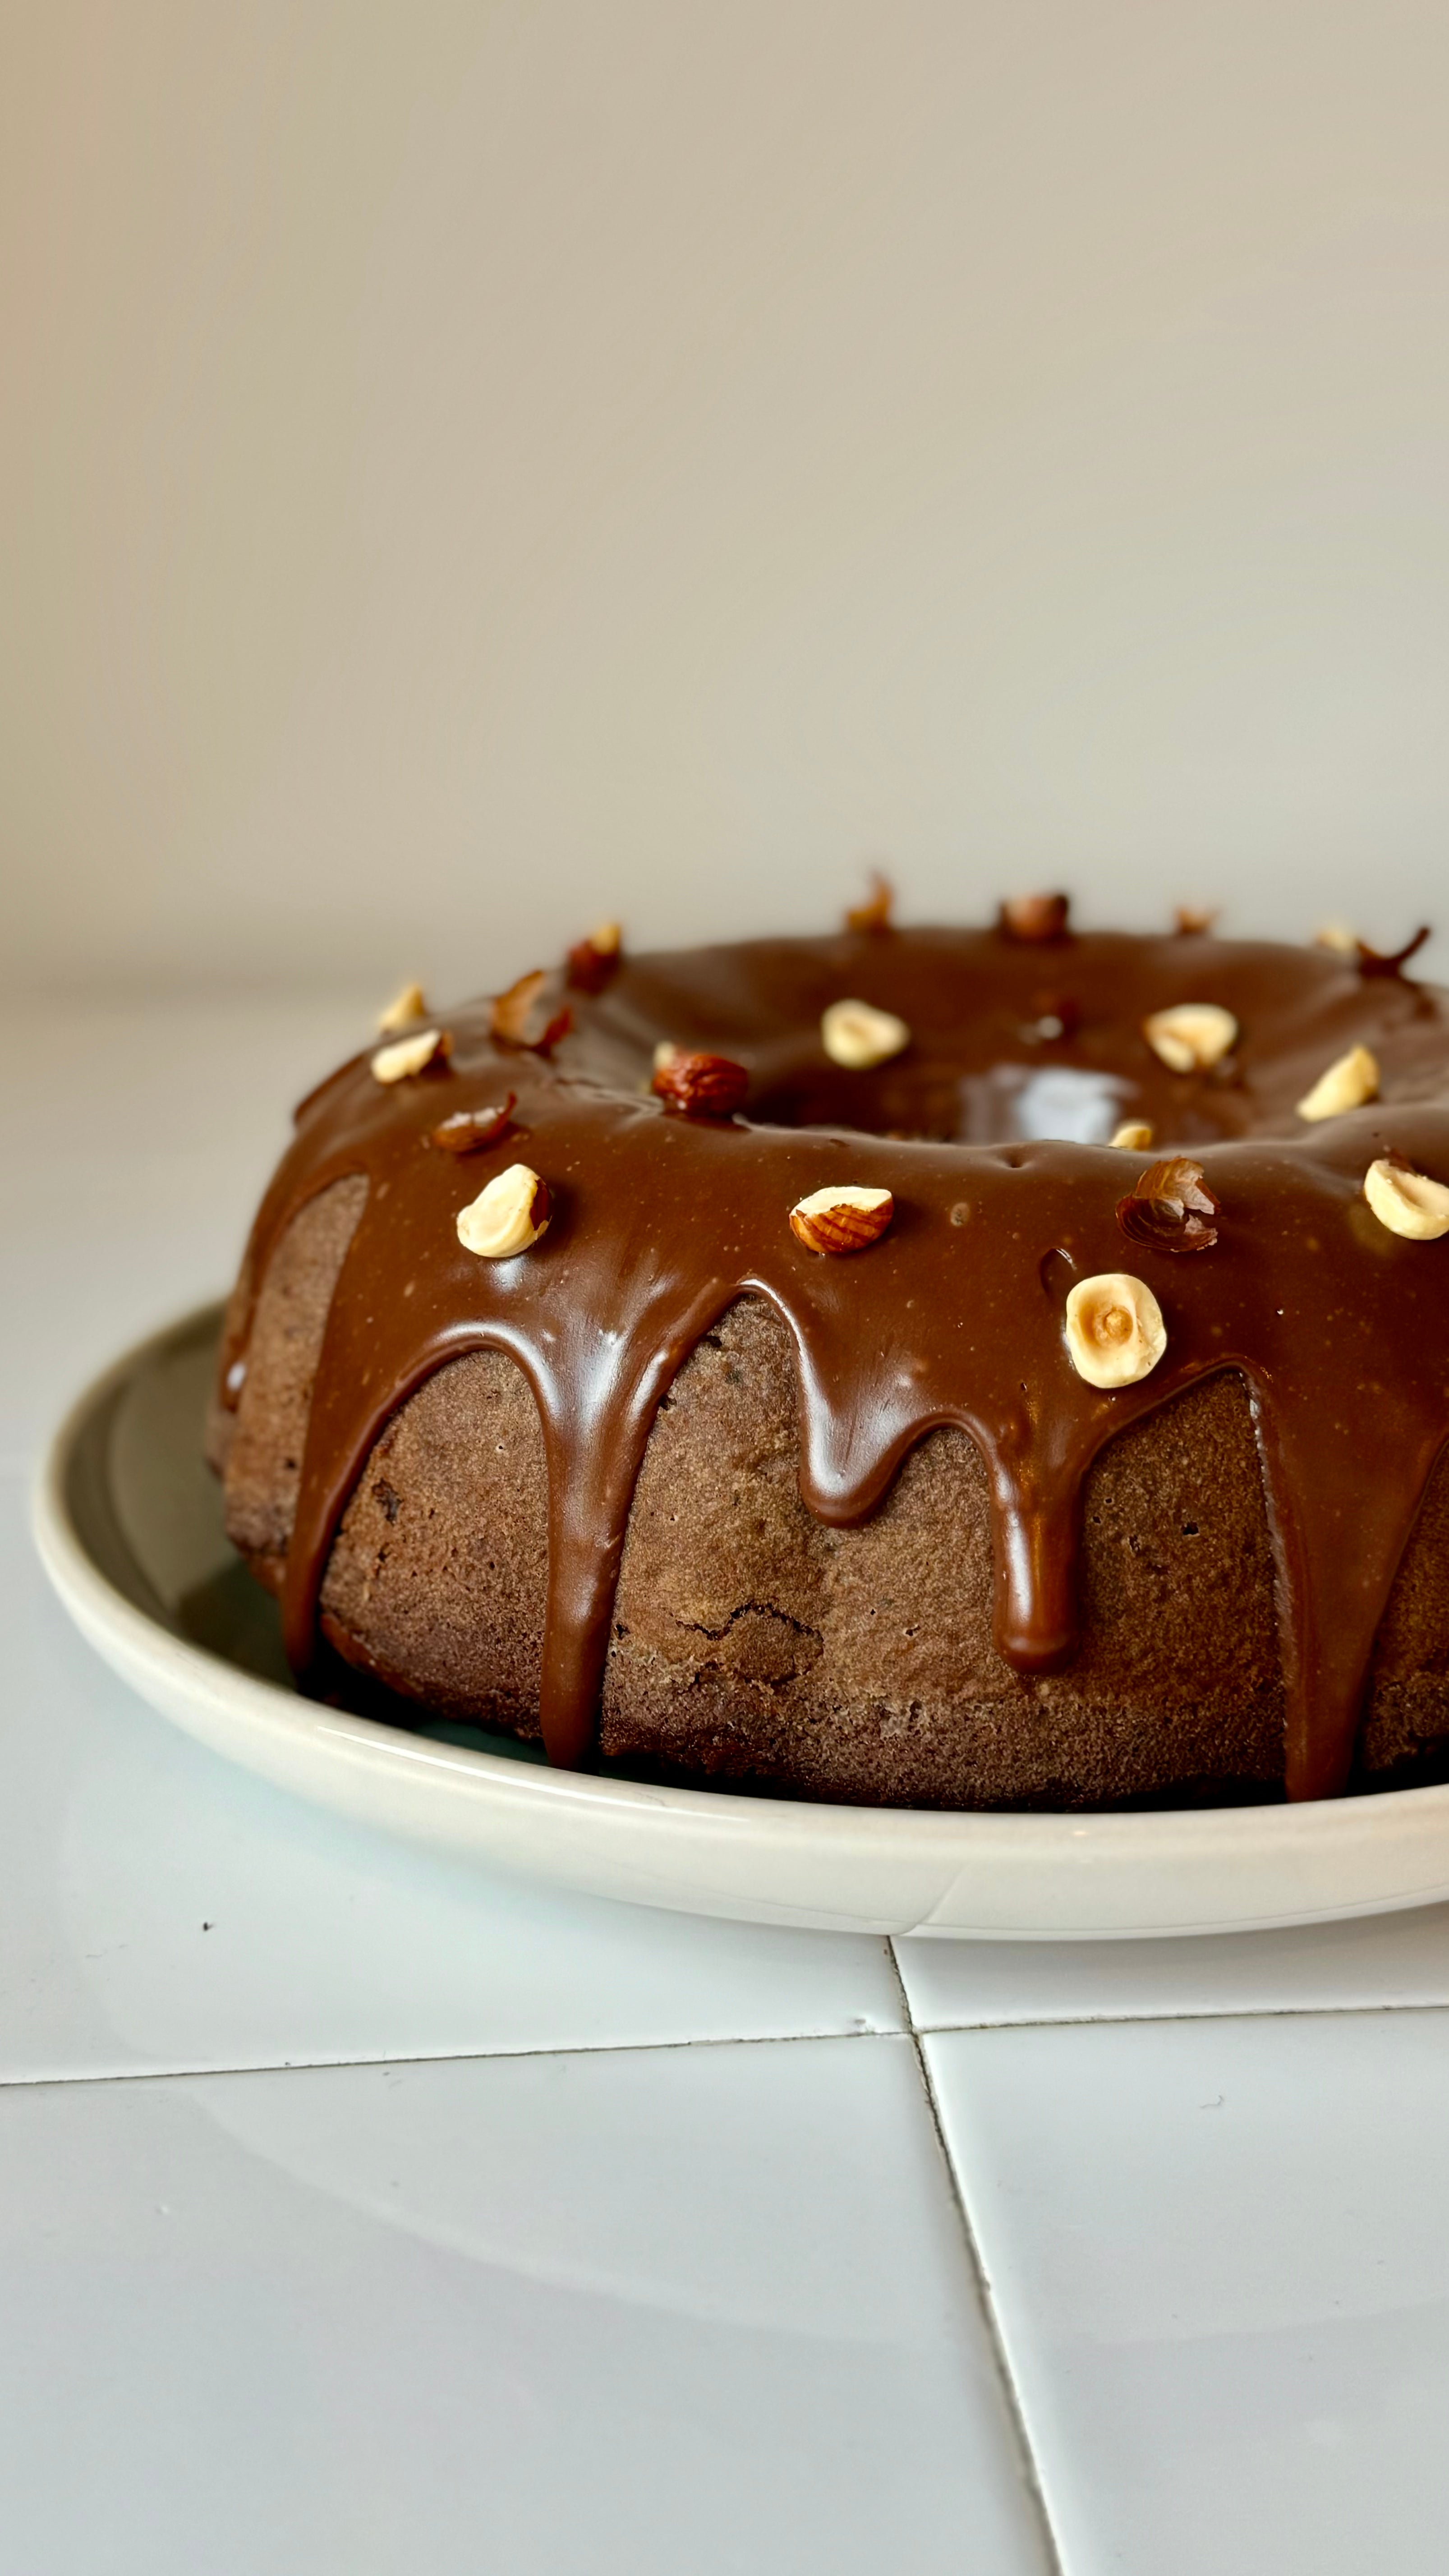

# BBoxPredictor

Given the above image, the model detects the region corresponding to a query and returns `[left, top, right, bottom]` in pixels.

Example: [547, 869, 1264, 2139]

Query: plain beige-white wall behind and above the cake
[0, 0, 1449, 989]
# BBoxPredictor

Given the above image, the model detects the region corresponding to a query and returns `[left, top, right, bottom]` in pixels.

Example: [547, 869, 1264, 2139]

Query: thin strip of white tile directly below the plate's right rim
[895, 1906, 1449, 2030]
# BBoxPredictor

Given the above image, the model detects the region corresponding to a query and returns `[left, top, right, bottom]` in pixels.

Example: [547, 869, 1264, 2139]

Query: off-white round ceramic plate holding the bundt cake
[36, 1306, 1449, 1940]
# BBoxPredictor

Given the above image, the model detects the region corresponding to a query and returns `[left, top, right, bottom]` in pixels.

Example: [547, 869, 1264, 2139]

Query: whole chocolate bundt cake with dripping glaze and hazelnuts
[212, 894, 1449, 1806]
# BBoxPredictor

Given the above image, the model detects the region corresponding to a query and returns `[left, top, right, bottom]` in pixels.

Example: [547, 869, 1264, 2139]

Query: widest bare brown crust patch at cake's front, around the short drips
[603, 1306, 1284, 1806]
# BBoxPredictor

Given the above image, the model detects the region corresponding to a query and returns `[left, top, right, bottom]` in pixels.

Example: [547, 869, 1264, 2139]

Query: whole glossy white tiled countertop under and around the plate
[0, 997, 1449, 2576]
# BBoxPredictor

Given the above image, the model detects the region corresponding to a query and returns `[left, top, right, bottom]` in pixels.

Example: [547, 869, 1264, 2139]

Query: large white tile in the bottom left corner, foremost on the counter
[0, 2040, 1044, 2576]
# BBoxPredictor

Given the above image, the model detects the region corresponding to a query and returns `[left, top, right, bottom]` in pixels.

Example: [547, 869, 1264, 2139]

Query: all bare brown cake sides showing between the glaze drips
[216, 1180, 1449, 1806]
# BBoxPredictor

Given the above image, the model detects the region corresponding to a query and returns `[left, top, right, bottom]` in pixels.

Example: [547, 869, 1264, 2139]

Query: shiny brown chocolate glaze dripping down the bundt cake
[222, 930, 1449, 1798]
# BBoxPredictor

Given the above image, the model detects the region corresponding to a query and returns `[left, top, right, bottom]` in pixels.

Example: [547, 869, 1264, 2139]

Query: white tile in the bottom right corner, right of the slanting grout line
[928, 2012, 1449, 2576]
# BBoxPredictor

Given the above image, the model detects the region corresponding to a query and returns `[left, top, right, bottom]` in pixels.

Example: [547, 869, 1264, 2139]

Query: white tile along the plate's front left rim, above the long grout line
[0, 1476, 900, 2079]
